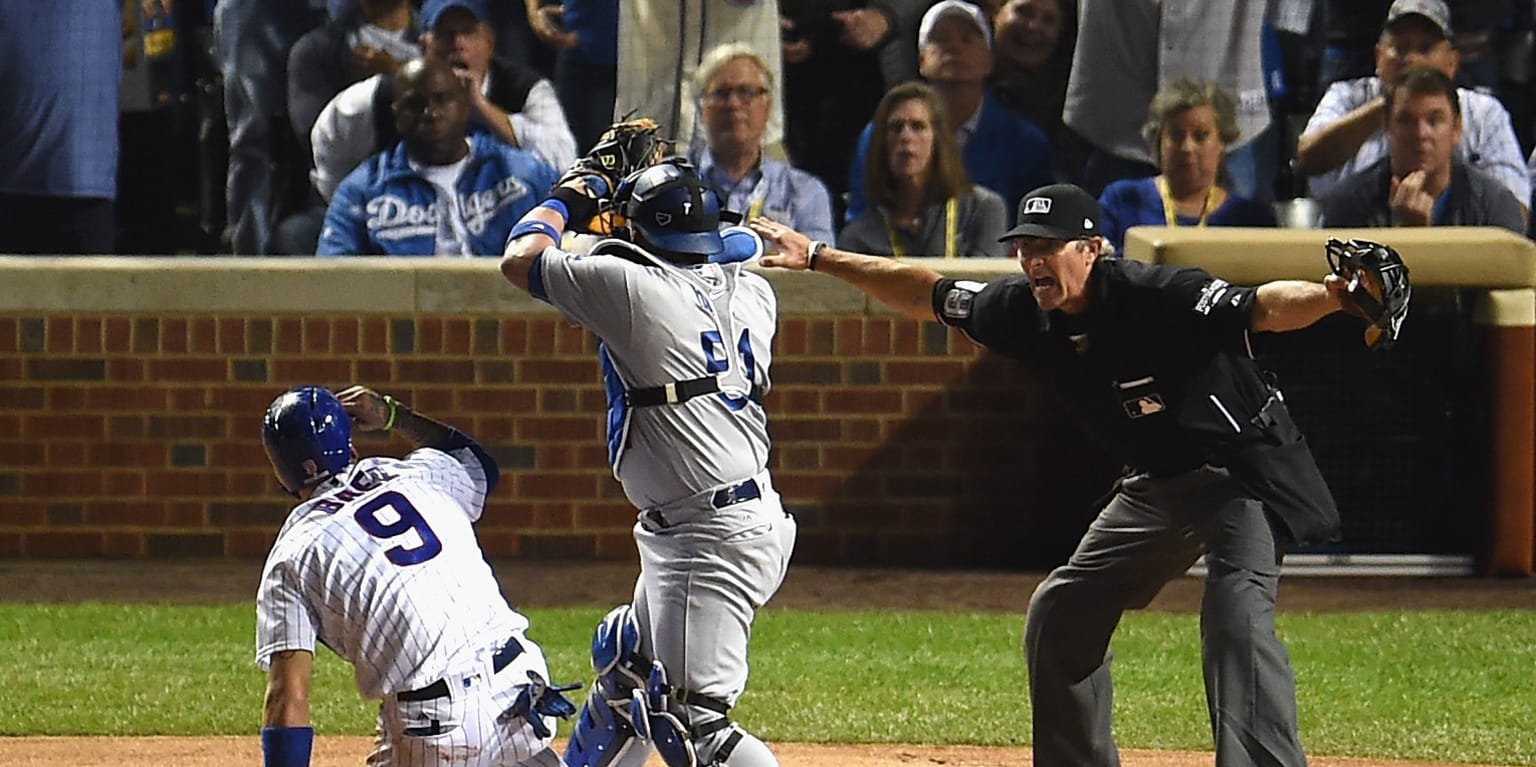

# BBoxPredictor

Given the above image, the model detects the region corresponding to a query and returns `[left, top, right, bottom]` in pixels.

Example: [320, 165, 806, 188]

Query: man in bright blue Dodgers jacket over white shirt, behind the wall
[318, 58, 558, 257]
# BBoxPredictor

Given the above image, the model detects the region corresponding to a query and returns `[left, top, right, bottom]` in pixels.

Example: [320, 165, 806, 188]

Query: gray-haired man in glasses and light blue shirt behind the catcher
[693, 43, 833, 243]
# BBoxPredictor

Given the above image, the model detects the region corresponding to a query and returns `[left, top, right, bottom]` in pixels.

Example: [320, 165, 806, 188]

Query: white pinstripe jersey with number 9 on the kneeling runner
[257, 447, 528, 698]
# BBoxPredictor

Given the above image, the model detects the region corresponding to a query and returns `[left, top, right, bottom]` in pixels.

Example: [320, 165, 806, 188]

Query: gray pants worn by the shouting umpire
[1025, 467, 1306, 767]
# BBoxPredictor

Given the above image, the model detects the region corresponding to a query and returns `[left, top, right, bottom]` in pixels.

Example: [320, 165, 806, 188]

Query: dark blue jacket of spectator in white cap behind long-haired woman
[846, 91, 1055, 226]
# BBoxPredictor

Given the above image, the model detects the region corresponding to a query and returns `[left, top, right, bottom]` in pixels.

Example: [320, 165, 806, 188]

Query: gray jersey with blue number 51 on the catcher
[530, 240, 779, 509]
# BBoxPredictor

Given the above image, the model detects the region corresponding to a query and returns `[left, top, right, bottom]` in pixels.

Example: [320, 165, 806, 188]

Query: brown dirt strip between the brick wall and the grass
[0, 559, 1536, 613]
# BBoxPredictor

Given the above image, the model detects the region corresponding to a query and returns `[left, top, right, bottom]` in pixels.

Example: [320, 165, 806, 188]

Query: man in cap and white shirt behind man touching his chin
[1296, 0, 1531, 211]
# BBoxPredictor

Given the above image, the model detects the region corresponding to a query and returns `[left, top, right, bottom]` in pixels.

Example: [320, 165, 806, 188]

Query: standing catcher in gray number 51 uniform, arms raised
[501, 129, 796, 767]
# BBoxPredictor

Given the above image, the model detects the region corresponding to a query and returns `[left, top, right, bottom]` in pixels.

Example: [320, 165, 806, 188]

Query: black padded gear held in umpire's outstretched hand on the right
[1326, 237, 1413, 349]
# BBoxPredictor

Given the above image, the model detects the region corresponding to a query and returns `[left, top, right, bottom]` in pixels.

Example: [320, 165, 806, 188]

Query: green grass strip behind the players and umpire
[0, 604, 1536, 765]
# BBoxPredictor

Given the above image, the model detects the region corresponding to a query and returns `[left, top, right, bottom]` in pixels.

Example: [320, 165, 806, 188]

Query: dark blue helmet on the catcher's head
[614, 157, 725, 255]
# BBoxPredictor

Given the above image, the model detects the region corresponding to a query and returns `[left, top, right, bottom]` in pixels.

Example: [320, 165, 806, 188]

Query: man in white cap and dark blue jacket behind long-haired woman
[846, 0, 1055, 223]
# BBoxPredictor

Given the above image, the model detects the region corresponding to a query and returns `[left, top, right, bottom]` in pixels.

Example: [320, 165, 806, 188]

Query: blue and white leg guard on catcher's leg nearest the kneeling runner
[564, 606, 647, 767]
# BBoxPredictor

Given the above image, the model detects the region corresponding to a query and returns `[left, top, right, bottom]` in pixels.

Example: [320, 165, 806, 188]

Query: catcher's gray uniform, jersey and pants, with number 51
[528, 231, 796, 767]
